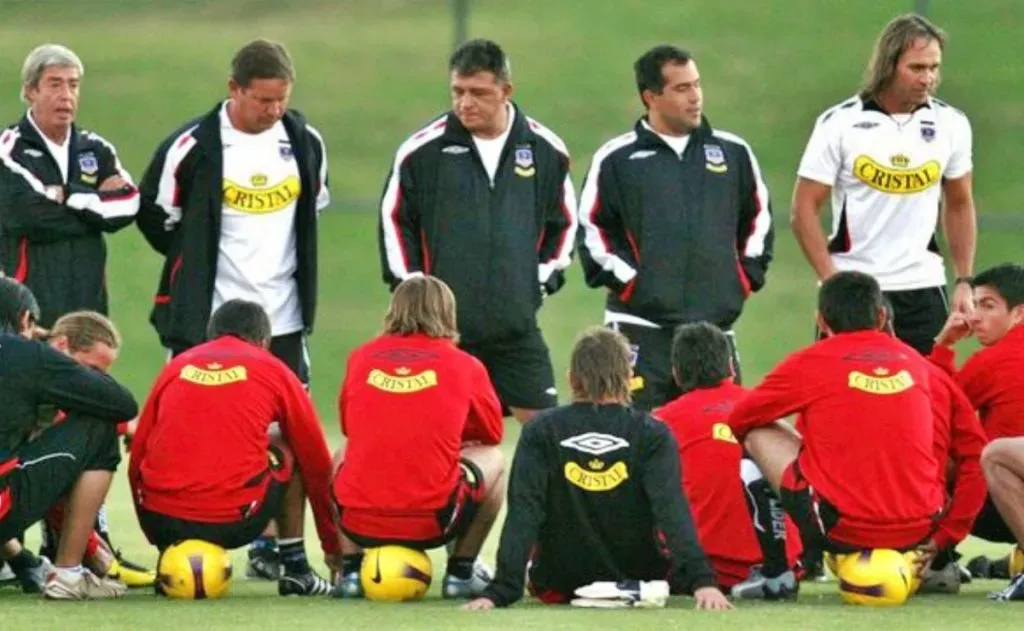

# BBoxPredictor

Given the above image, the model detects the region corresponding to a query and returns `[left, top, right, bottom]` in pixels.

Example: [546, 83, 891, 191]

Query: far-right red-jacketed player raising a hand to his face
[931, 263, 1024, 578]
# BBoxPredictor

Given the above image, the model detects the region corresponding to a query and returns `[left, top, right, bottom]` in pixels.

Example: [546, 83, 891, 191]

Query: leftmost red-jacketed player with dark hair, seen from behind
[128, 299, 341, 596]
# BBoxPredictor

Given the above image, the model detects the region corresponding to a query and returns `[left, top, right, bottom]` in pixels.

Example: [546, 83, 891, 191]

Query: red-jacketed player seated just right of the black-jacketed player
[653, 322, 803, 599]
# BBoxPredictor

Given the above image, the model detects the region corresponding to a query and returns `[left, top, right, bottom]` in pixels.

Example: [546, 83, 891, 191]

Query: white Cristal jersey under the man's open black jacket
[213, 104, 303, 335]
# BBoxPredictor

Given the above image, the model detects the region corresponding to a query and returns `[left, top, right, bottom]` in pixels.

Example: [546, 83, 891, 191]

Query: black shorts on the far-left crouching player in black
[0, 415, 121, 542]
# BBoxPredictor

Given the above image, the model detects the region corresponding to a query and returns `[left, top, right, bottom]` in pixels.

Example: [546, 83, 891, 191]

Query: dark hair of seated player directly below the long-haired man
[818, 271, 885, 333]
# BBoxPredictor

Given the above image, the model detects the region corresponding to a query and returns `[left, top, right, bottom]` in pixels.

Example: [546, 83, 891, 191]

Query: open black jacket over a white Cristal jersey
[137, 102, 327, 350]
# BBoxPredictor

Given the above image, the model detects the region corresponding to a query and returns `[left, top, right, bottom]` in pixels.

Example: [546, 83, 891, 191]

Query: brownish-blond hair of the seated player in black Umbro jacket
[569, 326, 633, 404]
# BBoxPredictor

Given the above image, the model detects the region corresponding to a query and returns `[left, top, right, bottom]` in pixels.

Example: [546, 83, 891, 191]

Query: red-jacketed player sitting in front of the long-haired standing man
[728, 271, 945, 565]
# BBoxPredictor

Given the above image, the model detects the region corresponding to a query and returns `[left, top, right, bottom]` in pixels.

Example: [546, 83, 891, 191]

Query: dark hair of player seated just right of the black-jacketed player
[672, 322, 732, 393]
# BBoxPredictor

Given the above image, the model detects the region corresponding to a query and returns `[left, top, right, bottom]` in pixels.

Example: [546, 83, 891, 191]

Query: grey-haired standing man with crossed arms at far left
[0, 44, 144, 585]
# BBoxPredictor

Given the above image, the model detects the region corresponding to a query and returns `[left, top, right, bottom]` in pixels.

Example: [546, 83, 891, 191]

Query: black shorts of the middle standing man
[461, 328, 558, 416]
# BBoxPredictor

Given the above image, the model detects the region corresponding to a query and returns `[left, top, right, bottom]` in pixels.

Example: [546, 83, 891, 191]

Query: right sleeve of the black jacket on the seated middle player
[642, 422, 715, 593]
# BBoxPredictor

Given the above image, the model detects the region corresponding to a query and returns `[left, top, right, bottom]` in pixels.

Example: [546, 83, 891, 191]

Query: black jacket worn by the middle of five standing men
[379, 107, 577, 342]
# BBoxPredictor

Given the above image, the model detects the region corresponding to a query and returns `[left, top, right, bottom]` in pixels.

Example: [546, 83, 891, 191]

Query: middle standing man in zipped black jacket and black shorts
[380, 40, 577, 422]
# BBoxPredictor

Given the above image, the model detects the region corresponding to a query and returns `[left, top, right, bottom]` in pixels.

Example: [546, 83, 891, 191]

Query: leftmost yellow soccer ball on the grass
[157, 539, 231, 600]
